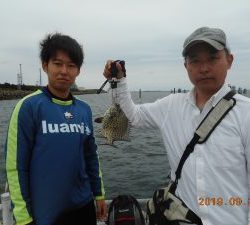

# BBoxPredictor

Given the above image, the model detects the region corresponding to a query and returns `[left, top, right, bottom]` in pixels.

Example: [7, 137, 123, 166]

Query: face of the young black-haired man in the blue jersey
[43, 51, 80, 95]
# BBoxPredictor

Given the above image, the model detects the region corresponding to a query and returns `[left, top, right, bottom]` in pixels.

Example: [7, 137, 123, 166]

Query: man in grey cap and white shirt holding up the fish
[103, 27, 250, 225]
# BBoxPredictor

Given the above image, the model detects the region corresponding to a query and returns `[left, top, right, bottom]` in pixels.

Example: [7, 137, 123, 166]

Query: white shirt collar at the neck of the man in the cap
[186, 83, 231, 107]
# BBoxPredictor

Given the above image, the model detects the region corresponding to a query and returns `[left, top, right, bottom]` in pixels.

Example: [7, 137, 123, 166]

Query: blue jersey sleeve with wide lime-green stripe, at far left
[6, 99, 35, 225]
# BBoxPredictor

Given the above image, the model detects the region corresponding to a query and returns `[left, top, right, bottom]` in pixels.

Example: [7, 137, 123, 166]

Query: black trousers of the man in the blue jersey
[53, 201, 96, 225]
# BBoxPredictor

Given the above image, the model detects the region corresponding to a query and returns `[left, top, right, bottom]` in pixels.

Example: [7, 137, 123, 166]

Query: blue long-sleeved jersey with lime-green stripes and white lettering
[6, 88, 104, 225]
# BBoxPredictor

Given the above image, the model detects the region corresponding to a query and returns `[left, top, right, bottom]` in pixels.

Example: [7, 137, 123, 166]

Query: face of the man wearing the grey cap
[184, 43, 233, 94]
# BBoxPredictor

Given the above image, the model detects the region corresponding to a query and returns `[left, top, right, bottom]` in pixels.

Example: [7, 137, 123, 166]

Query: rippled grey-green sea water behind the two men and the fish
[0, 91, 170, 199]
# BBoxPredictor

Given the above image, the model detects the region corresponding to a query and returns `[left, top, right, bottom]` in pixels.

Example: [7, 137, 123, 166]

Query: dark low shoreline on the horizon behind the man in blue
[0, 88, 104, 100]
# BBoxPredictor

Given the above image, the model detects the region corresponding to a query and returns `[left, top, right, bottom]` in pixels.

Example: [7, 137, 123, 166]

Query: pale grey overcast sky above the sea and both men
[0, 0, 250, 90]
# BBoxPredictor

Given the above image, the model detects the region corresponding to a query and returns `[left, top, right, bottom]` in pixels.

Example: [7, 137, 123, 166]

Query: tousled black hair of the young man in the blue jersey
[40, 33, 84, 69]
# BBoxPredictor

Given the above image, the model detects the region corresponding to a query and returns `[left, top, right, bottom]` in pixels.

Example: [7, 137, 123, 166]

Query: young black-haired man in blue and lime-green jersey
[6, 33, 106, 225]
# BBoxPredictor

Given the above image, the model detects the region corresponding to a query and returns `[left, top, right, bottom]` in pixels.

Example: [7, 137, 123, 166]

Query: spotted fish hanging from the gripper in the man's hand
[94, 103, 131, 146]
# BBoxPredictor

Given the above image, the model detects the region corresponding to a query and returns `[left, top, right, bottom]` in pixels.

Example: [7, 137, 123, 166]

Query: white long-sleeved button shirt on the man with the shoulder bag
[115, 78, 250, 225]
